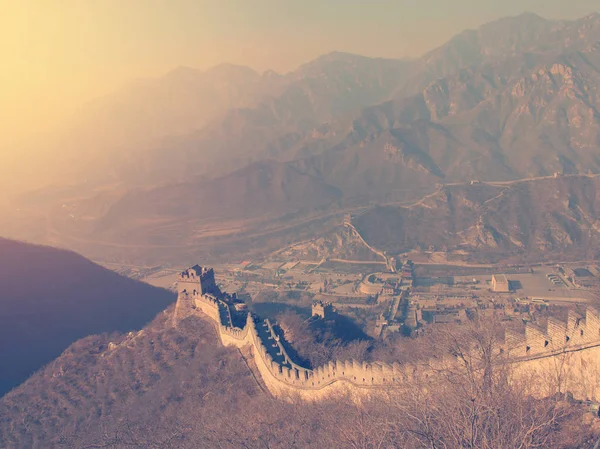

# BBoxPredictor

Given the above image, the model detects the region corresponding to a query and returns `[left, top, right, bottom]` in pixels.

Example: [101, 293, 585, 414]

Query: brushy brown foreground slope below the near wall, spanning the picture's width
[0, 300, 598, 449]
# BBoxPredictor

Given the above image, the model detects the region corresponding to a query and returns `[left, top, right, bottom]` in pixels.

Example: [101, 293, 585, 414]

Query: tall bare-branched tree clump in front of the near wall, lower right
[382, 321, 580, 449]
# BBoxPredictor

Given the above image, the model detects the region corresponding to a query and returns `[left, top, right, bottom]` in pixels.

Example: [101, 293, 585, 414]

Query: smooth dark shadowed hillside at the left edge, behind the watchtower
[0, 239, 175, 396]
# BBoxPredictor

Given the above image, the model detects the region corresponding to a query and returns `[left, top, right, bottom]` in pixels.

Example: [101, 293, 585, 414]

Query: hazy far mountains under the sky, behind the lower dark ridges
[56, 10, 600, 184]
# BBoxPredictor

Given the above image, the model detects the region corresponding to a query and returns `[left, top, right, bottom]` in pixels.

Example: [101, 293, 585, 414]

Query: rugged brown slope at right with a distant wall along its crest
[355, 176, 600, 260]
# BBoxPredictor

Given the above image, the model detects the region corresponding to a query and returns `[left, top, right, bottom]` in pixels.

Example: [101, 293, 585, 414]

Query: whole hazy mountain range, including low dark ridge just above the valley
[7, 14, 600, 262]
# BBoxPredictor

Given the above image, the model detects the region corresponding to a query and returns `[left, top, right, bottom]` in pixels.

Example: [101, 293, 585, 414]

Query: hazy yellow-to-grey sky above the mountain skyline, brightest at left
[0, 0, 600, 154]
